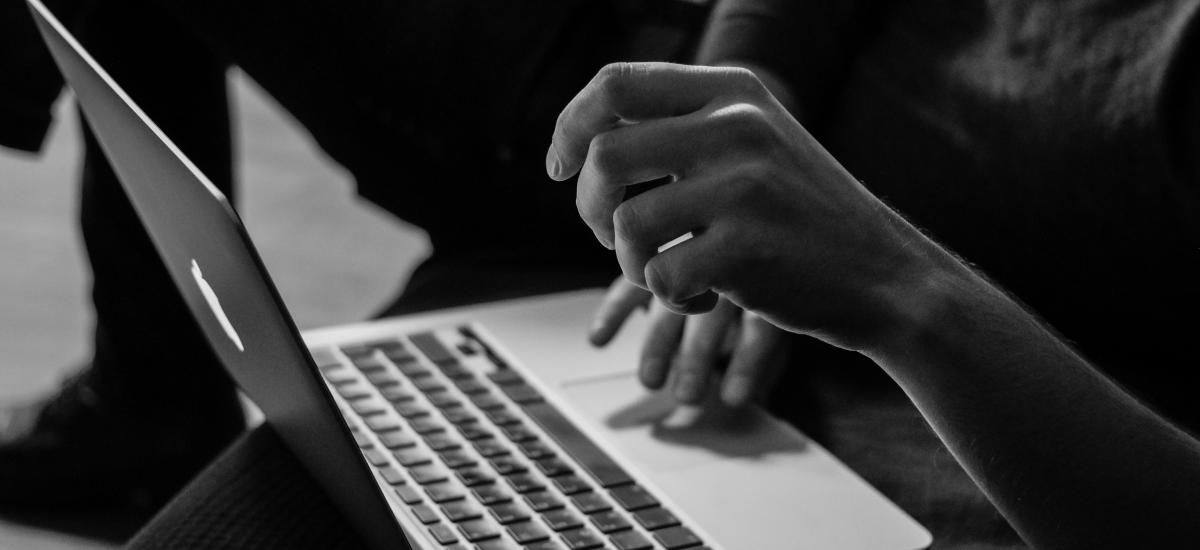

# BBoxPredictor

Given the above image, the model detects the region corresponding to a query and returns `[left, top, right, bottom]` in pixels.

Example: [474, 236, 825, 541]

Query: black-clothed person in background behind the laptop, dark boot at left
[0, 0, 704, 512]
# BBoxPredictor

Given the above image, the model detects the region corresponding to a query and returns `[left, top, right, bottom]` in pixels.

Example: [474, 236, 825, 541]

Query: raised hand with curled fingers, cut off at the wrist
[546, 64, 929, 349]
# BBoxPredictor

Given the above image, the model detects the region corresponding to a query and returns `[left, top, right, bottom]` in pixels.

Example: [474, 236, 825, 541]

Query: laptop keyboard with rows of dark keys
[313, 327, 704, 550]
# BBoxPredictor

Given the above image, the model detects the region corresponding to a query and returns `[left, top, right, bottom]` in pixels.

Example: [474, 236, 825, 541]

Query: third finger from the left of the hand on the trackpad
[673, 300, 740, 403]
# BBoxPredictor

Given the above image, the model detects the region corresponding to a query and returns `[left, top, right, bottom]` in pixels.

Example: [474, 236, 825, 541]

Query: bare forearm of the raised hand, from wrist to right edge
[868, 248, 1200, 548]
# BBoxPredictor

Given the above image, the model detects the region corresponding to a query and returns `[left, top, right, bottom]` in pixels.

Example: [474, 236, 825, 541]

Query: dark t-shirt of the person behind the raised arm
[703, 0, 1200, 429]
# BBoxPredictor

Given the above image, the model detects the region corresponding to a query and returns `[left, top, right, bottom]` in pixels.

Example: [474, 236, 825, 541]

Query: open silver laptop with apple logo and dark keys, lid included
[28, 0, 931, 550]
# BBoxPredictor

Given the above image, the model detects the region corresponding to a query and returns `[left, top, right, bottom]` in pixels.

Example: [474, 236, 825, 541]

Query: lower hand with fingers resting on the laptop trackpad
[588, 277, 787, 407]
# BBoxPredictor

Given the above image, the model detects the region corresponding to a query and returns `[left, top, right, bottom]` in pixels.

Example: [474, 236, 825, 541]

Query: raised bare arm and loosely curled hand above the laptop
[546, 64, 1200, 549]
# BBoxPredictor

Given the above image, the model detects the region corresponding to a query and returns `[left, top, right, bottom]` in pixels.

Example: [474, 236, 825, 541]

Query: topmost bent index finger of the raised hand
[546, 62, 761, 181]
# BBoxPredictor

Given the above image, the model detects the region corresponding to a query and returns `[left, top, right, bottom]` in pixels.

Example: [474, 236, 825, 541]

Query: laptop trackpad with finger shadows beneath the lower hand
[563, 373, 806, 472]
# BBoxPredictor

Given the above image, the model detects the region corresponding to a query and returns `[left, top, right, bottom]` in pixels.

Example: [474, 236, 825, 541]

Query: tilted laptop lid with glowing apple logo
[28, 0, 410, 549]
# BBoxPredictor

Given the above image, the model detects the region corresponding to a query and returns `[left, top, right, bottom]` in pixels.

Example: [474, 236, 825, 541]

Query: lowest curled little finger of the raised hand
[644, 219, 731, 315]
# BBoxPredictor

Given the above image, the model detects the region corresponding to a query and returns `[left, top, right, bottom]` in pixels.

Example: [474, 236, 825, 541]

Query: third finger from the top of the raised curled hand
[612, 174, 721, 288]
